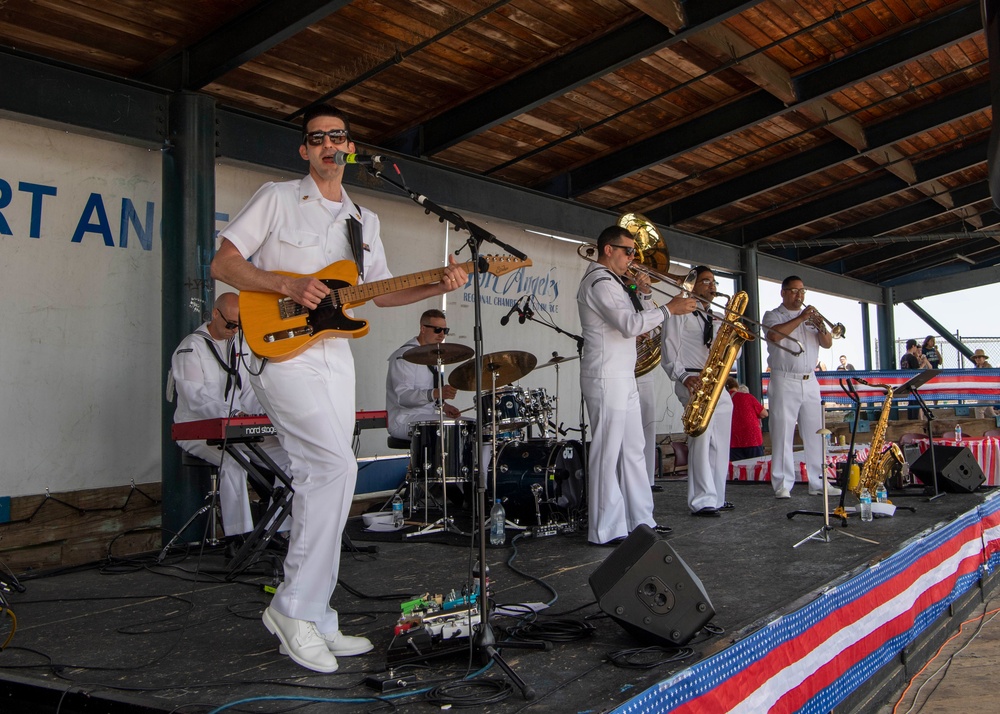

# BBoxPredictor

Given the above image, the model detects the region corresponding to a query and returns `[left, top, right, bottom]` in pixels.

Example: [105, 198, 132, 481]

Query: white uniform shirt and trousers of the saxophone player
[660, 313, 733, 513]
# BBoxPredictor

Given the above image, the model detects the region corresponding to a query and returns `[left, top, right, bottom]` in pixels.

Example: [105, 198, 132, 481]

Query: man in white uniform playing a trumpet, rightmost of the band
[761, 275, 840, 498]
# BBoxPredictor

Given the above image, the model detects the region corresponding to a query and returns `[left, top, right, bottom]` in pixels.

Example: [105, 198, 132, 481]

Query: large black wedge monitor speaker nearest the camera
[590, 526, 715, 645]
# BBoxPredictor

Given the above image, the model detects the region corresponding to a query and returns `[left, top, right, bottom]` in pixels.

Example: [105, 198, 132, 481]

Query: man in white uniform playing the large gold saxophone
[660, 265, 733, 518]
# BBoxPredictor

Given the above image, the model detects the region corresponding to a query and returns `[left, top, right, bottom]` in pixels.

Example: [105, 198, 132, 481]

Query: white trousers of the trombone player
[580, 376, 656, 543]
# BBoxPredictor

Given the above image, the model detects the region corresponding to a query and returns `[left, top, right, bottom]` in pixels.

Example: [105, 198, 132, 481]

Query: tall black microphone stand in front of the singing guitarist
[365, 160, 550, 700]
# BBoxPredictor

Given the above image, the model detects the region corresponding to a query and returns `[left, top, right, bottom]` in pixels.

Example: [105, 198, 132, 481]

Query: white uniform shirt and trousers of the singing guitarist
[222, 176, 392, 634]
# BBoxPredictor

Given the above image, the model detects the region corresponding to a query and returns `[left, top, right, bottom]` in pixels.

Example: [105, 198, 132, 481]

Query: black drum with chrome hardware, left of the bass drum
[410, 419, 476, 483]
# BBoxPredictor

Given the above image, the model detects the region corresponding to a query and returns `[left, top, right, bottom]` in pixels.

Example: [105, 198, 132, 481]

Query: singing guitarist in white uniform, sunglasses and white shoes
[212, 105, 468, 672]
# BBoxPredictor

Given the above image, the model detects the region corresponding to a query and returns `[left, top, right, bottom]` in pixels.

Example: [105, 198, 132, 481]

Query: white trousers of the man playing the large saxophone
[684, 389, 733, 513]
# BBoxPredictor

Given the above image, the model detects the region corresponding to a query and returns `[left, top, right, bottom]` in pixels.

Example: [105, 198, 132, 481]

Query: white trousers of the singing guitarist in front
[251, 339, 358, 633]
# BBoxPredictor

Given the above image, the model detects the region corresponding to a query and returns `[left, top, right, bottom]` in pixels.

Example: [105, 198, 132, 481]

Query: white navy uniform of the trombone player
[576, 263, 670, 543]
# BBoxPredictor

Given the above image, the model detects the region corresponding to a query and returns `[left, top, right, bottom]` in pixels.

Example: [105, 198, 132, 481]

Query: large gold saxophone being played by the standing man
[681, 290, 754, 436]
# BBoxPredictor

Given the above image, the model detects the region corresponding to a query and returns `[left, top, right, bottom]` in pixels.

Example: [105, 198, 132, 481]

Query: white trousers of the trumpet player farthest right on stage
[767, 372, 823, 492]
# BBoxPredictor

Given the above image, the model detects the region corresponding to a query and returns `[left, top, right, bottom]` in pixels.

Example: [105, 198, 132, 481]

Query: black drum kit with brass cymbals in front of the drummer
[402, 343, 586, 535]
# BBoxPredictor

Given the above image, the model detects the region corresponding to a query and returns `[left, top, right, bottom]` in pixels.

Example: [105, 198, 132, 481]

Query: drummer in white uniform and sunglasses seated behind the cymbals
[385, 309, 461, 439]
